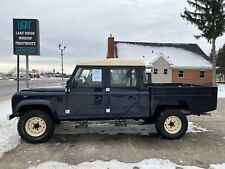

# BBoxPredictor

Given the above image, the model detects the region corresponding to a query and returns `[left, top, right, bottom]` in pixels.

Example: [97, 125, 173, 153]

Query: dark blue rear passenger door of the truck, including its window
[106, 67, 140, 118]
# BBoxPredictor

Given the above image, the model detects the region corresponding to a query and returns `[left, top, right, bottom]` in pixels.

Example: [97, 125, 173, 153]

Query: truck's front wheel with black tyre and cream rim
[17, 110, 55, 143]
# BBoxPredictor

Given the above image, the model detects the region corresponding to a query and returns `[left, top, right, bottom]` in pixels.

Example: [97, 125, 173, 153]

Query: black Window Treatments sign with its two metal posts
[13, 19, 40, 91]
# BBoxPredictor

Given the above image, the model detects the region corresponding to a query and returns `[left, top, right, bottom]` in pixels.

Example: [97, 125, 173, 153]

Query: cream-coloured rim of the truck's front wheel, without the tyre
[25, 117, 46, 137]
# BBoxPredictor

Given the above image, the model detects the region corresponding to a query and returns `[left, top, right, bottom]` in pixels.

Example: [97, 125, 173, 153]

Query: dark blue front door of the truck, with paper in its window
[68, 66, 106, 119]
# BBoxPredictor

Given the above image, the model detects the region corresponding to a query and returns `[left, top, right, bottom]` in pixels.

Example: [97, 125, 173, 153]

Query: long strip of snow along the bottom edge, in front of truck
[29, 158, 200, 169]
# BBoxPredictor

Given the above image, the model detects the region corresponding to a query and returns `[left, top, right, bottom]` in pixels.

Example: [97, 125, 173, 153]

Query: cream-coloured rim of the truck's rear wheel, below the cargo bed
[164, 116, 182, 134]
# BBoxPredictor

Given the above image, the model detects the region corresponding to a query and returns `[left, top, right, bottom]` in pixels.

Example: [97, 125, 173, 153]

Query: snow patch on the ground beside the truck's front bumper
[0, 100, 20, 158]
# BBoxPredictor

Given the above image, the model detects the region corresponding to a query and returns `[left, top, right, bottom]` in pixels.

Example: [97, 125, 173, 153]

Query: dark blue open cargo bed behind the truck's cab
[149, 84, 217, 115]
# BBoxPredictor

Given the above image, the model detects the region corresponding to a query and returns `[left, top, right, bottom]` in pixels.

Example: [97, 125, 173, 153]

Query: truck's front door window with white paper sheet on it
[74, 68, 102, 87]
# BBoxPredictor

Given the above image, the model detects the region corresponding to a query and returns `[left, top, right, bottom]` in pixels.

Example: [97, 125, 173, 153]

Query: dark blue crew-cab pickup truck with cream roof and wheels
[9, 59, 217, 143]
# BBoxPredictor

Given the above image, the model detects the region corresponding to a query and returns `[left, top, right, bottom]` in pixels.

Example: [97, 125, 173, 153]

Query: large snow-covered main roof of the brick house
[115, 41, 212, 68]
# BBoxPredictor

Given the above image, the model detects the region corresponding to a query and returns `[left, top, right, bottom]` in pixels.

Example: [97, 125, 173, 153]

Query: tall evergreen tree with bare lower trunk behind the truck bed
[181, 0, 225, 86]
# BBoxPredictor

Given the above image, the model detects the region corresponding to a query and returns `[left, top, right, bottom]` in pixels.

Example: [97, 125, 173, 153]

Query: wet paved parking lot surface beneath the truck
[0, 99, 225, 169]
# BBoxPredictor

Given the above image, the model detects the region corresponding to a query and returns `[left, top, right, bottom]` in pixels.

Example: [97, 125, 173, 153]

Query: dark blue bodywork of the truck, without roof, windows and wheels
[10, 65, 217, 120]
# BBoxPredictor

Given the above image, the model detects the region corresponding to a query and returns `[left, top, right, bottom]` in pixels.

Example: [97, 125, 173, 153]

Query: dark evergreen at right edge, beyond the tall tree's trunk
[217, 44, 225, 75]
